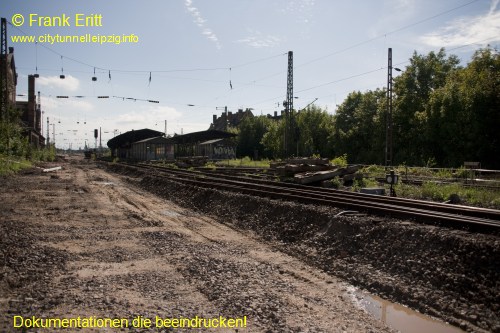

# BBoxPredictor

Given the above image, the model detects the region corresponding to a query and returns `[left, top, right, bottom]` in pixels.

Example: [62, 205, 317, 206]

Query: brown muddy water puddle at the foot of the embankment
[348, 289, 465, 333]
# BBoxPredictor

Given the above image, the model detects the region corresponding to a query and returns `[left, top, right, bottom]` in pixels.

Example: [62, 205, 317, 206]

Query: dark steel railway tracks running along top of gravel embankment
[112, 163, 500, 231]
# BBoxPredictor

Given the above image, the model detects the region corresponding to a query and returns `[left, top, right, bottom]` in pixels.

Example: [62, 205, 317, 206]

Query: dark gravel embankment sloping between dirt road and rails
[104, 166, 500, 332]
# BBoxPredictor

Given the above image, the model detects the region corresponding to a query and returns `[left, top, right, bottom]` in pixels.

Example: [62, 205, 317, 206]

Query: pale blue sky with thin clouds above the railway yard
[0, 0, 500, 149]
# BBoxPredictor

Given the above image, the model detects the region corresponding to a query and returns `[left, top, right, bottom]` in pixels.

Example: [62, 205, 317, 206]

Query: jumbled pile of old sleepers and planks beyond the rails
[271, 158, 363, 187]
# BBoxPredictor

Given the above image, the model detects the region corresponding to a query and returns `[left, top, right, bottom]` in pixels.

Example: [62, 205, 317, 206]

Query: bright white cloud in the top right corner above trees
[421, 4, 500, 47]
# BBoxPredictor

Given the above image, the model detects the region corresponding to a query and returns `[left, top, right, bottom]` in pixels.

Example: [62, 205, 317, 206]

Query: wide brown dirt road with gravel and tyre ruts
[0, 160, 390, 332]
